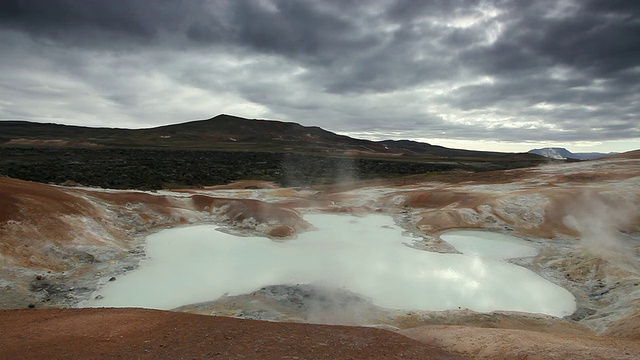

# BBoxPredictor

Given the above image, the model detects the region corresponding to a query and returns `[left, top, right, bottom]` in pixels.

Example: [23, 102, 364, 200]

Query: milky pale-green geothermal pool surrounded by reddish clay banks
[85, 214, 576, 316]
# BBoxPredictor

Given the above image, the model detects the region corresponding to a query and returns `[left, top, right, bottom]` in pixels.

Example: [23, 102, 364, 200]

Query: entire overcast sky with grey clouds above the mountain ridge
[0, 0, 640, 152]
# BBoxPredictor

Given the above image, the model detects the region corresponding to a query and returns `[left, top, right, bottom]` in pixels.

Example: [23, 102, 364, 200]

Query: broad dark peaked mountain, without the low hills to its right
[0, 115, 389, 153]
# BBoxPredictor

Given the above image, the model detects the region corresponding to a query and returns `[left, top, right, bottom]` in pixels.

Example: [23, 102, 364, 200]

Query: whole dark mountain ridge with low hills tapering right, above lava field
[0, 114, 537, 161]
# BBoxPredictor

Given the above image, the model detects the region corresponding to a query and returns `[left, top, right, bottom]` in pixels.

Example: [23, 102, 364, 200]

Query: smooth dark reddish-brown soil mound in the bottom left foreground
[0, 309, 464, 359]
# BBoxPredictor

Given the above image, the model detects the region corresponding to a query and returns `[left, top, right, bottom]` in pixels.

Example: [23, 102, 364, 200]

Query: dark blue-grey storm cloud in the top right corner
[466, 1, 640, 77]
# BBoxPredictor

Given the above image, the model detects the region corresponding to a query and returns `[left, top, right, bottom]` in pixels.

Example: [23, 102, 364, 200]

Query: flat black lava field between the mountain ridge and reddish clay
[0, 147, 464, 190]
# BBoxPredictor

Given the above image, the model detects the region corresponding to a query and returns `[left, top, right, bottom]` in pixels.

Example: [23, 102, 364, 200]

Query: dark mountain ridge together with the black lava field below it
[0, 115, 547, 190]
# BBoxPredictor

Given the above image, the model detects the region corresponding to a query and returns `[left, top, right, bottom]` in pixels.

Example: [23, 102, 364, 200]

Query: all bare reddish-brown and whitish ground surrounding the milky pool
[0, 151, 640, 359]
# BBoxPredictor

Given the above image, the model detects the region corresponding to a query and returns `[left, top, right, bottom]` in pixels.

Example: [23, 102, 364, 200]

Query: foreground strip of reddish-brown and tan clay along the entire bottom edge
[0, 309, 640, 360]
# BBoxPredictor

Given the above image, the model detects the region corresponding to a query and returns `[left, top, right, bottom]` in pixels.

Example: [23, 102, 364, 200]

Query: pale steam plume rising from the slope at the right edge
[563, 190, 638, 273]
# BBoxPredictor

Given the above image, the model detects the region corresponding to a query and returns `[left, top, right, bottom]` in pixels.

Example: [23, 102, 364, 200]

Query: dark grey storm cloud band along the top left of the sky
[0, 0, 369, 58]
